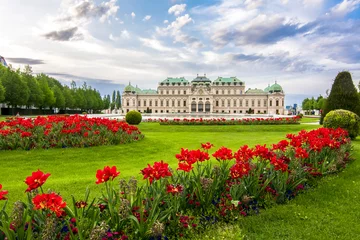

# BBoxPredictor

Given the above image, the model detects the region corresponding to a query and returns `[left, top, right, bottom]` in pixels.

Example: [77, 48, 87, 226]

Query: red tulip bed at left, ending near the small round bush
[0, 115, 144, 150]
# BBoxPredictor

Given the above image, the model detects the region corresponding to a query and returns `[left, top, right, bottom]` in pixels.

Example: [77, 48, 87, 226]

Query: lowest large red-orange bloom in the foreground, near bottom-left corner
[32, 193, 66, 217]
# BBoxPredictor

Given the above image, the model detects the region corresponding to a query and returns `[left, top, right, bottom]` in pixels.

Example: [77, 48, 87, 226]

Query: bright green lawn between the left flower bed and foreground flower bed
[0, 123, 318, 209]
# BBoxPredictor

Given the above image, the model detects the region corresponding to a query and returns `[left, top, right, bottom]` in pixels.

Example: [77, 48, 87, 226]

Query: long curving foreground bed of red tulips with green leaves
[0, 128, 351, 239]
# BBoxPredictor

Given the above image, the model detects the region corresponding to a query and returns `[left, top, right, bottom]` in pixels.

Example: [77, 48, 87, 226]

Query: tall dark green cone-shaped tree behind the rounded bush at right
[320, 71, 360, 124]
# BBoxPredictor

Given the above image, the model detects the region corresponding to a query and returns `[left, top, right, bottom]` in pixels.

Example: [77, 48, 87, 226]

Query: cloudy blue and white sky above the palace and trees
[0, 0, 360, 105]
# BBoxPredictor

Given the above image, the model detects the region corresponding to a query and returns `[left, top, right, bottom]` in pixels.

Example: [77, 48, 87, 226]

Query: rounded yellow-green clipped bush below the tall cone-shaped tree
[324, 109, 360, 139]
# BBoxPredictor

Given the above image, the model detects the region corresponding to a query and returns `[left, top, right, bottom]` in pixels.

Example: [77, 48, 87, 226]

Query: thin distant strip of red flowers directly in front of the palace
[147, 116, 300, 125]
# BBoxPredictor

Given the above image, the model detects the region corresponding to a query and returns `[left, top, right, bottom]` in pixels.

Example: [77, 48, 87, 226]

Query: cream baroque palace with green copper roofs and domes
[122, 75, 285, 114]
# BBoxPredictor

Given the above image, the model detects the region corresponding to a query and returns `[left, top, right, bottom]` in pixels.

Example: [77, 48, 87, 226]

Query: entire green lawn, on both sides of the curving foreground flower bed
[0, 123, 360, 239]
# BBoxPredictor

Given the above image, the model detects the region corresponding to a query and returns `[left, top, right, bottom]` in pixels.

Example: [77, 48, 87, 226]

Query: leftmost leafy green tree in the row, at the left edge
[1, 69, 30, 107]
